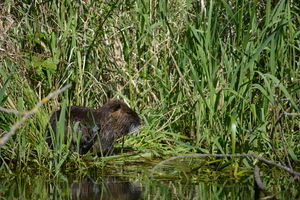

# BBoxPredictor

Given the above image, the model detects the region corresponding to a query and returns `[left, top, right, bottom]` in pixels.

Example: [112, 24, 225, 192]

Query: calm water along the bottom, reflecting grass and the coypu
[0, 165, 298, 200]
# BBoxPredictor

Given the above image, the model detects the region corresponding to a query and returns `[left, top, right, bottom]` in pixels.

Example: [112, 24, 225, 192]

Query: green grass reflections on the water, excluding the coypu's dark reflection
[0, 165, 297, 199]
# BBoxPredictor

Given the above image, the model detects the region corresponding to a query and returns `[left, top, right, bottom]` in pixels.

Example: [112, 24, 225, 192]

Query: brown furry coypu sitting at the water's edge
[46, 99, 142, 156]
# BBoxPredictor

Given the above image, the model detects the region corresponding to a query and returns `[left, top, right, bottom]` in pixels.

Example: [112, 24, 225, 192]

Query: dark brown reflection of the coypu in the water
[71, 176, 142, 200]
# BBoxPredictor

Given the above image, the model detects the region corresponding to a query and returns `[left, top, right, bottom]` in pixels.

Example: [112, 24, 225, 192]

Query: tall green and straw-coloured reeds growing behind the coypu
[0, 0, 300, 181]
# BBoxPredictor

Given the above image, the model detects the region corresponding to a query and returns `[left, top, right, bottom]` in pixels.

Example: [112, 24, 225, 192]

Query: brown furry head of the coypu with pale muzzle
[99, 99, 142, 137]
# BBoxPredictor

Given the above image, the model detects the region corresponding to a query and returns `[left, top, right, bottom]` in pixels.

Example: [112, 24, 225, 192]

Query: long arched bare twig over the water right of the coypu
[151, 154, 300, 178]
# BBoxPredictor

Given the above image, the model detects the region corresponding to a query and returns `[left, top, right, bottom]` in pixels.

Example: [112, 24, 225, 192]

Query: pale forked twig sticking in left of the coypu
[0, 84, 72, 146]
